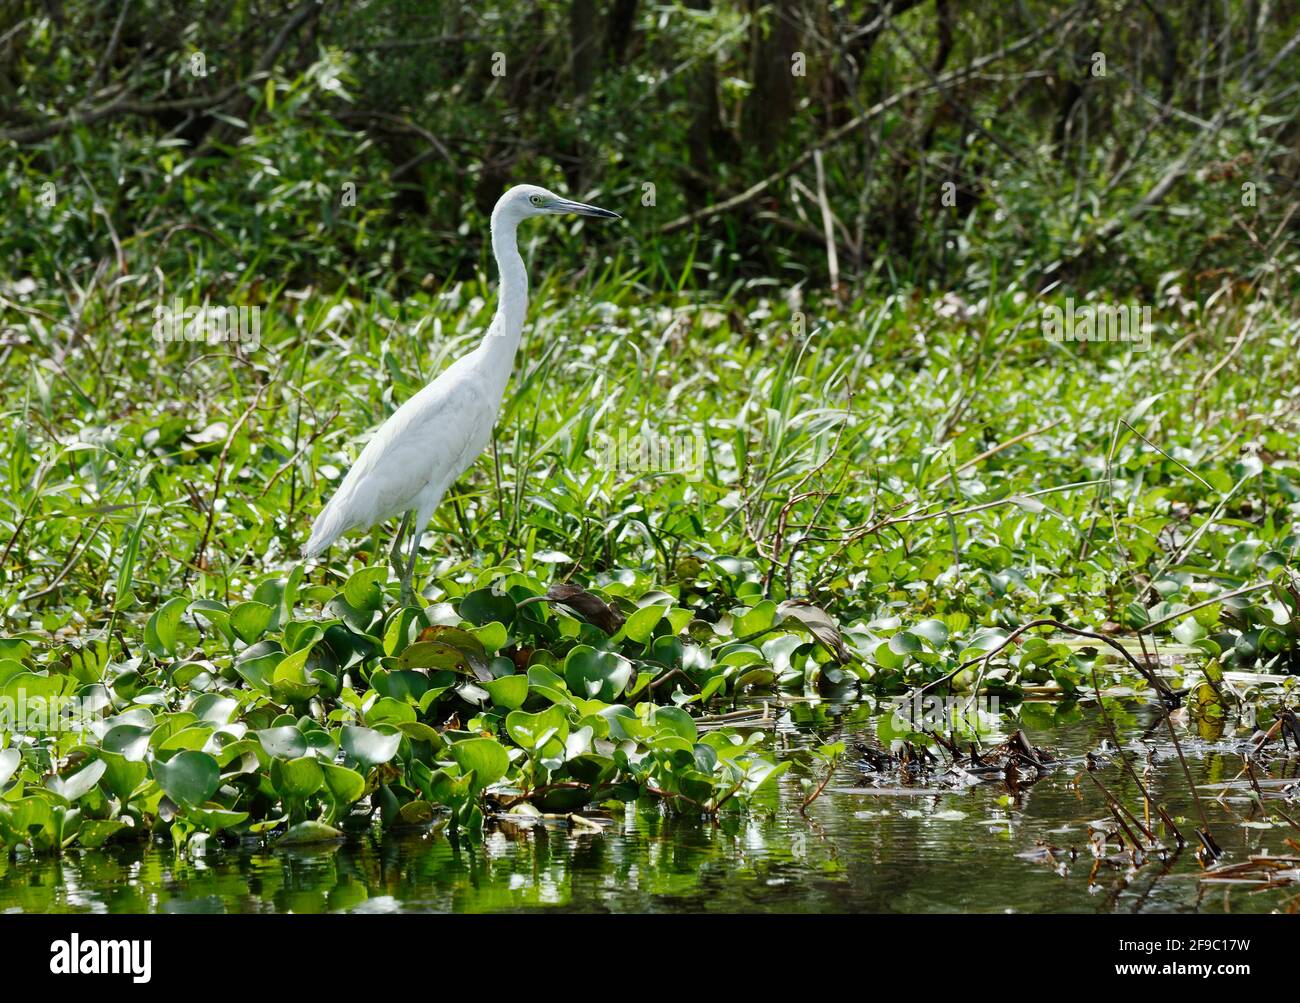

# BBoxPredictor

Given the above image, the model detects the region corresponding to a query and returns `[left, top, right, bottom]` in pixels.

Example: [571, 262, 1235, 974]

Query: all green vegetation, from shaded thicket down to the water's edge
[0, 3, 1300, 850]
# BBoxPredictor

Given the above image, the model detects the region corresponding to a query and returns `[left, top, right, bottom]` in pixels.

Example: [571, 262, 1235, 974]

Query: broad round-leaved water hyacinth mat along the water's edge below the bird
[0, 524, 1294, 852]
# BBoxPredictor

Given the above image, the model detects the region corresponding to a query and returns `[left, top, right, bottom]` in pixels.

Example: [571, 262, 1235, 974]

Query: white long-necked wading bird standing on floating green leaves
[303, 184, 621, 603]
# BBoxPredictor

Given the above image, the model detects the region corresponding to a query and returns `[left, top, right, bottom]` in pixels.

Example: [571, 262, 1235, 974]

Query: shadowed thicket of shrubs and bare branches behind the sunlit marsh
[0, 0, 1300, 294]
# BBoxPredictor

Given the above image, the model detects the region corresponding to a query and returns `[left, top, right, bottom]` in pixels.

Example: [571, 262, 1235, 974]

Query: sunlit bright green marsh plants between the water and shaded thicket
[0, 278, 1300, 846]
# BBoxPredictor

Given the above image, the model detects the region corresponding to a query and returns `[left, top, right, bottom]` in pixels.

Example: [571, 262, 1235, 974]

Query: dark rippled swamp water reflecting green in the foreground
[0, 702, 1300, 913]
